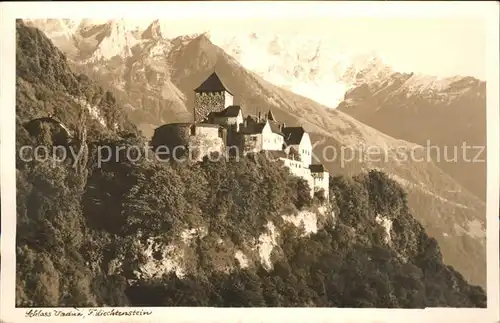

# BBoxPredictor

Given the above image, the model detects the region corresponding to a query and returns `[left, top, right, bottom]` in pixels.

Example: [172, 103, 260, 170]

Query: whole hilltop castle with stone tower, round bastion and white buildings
[151, 73, 329, 198]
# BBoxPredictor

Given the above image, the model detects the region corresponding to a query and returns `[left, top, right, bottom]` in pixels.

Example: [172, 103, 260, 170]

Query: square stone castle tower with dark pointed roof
[194, 72, 233, 122]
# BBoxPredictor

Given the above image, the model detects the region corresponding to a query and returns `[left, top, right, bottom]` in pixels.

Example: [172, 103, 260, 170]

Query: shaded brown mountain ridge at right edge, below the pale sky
[338, 71, 486, 201]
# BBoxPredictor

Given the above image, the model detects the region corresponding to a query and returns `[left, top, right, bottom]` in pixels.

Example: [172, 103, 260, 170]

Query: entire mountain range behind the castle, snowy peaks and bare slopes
[22, 20, 486, 287]
